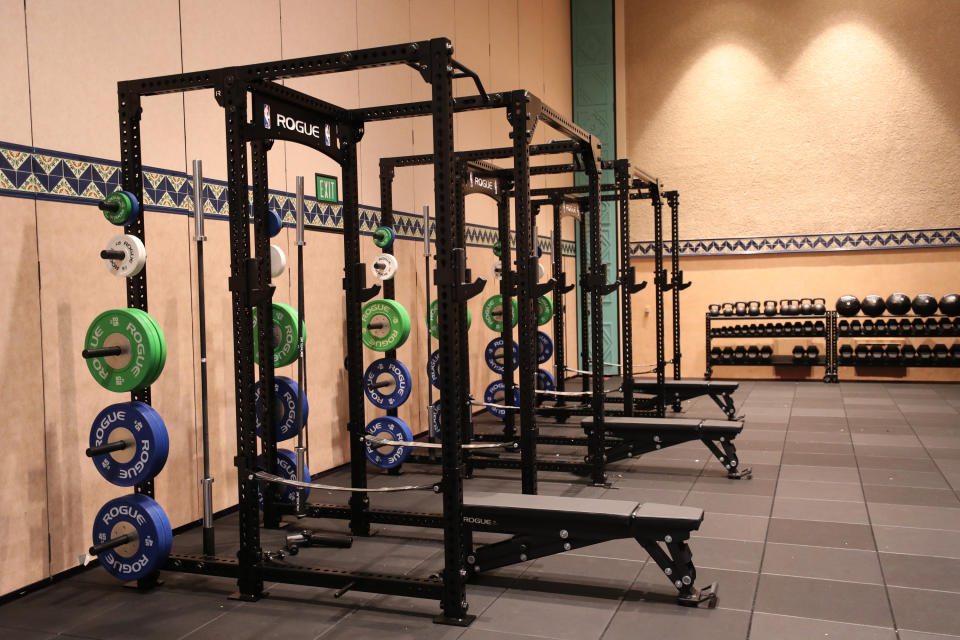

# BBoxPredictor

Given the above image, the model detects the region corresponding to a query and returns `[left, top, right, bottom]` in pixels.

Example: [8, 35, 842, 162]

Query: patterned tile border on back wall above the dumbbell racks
[630, 228, 960, 257]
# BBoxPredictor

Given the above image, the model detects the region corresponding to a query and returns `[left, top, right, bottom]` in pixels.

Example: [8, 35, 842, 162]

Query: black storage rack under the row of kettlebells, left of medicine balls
[704, 311, 837, 382]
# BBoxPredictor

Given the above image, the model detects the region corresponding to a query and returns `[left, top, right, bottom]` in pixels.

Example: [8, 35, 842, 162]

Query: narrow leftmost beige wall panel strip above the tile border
[0, 2, 32, 145]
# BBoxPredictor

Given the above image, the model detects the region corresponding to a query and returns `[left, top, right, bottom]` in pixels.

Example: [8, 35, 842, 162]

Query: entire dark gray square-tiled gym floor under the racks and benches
[0, 382, 960, 640]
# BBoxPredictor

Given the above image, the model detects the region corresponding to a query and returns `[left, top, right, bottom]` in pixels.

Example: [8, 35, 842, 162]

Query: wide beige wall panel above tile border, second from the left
[27, 0, 183, 168]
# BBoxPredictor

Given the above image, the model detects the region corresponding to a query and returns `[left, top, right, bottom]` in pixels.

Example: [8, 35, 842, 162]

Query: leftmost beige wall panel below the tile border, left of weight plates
[0, 198, 47, 594]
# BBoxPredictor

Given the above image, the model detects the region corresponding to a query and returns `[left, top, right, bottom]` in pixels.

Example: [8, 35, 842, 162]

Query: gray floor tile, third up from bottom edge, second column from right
[761, 543, 883, 584]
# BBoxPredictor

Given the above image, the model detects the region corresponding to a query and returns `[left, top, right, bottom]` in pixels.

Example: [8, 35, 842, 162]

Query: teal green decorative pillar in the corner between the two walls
[570, 0, 620, 373]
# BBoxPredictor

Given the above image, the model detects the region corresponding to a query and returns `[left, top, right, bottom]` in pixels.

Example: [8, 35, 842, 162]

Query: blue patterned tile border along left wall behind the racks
[0, 142, 576, 257]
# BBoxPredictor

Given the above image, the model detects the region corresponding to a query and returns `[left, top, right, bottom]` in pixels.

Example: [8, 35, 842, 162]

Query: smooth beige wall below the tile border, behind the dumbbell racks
[633, 249, 960, 381]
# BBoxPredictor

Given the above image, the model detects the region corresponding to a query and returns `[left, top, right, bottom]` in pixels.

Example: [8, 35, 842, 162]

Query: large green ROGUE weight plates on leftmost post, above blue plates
[83, 309, 161, 393]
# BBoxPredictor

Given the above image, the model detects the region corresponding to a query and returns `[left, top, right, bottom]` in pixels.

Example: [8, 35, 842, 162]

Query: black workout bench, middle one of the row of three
[580, 417, 751, 480]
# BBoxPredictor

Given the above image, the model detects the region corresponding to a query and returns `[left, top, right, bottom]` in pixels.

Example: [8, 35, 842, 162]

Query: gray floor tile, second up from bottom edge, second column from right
[755, 574, 893, 627]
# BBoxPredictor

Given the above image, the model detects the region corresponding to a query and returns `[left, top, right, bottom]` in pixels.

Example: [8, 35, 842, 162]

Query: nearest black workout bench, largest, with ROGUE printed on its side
[463, 493, 717, 608]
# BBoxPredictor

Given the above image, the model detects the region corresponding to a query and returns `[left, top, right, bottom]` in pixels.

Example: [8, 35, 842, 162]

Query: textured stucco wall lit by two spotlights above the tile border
[620, 0, 960, 239]
